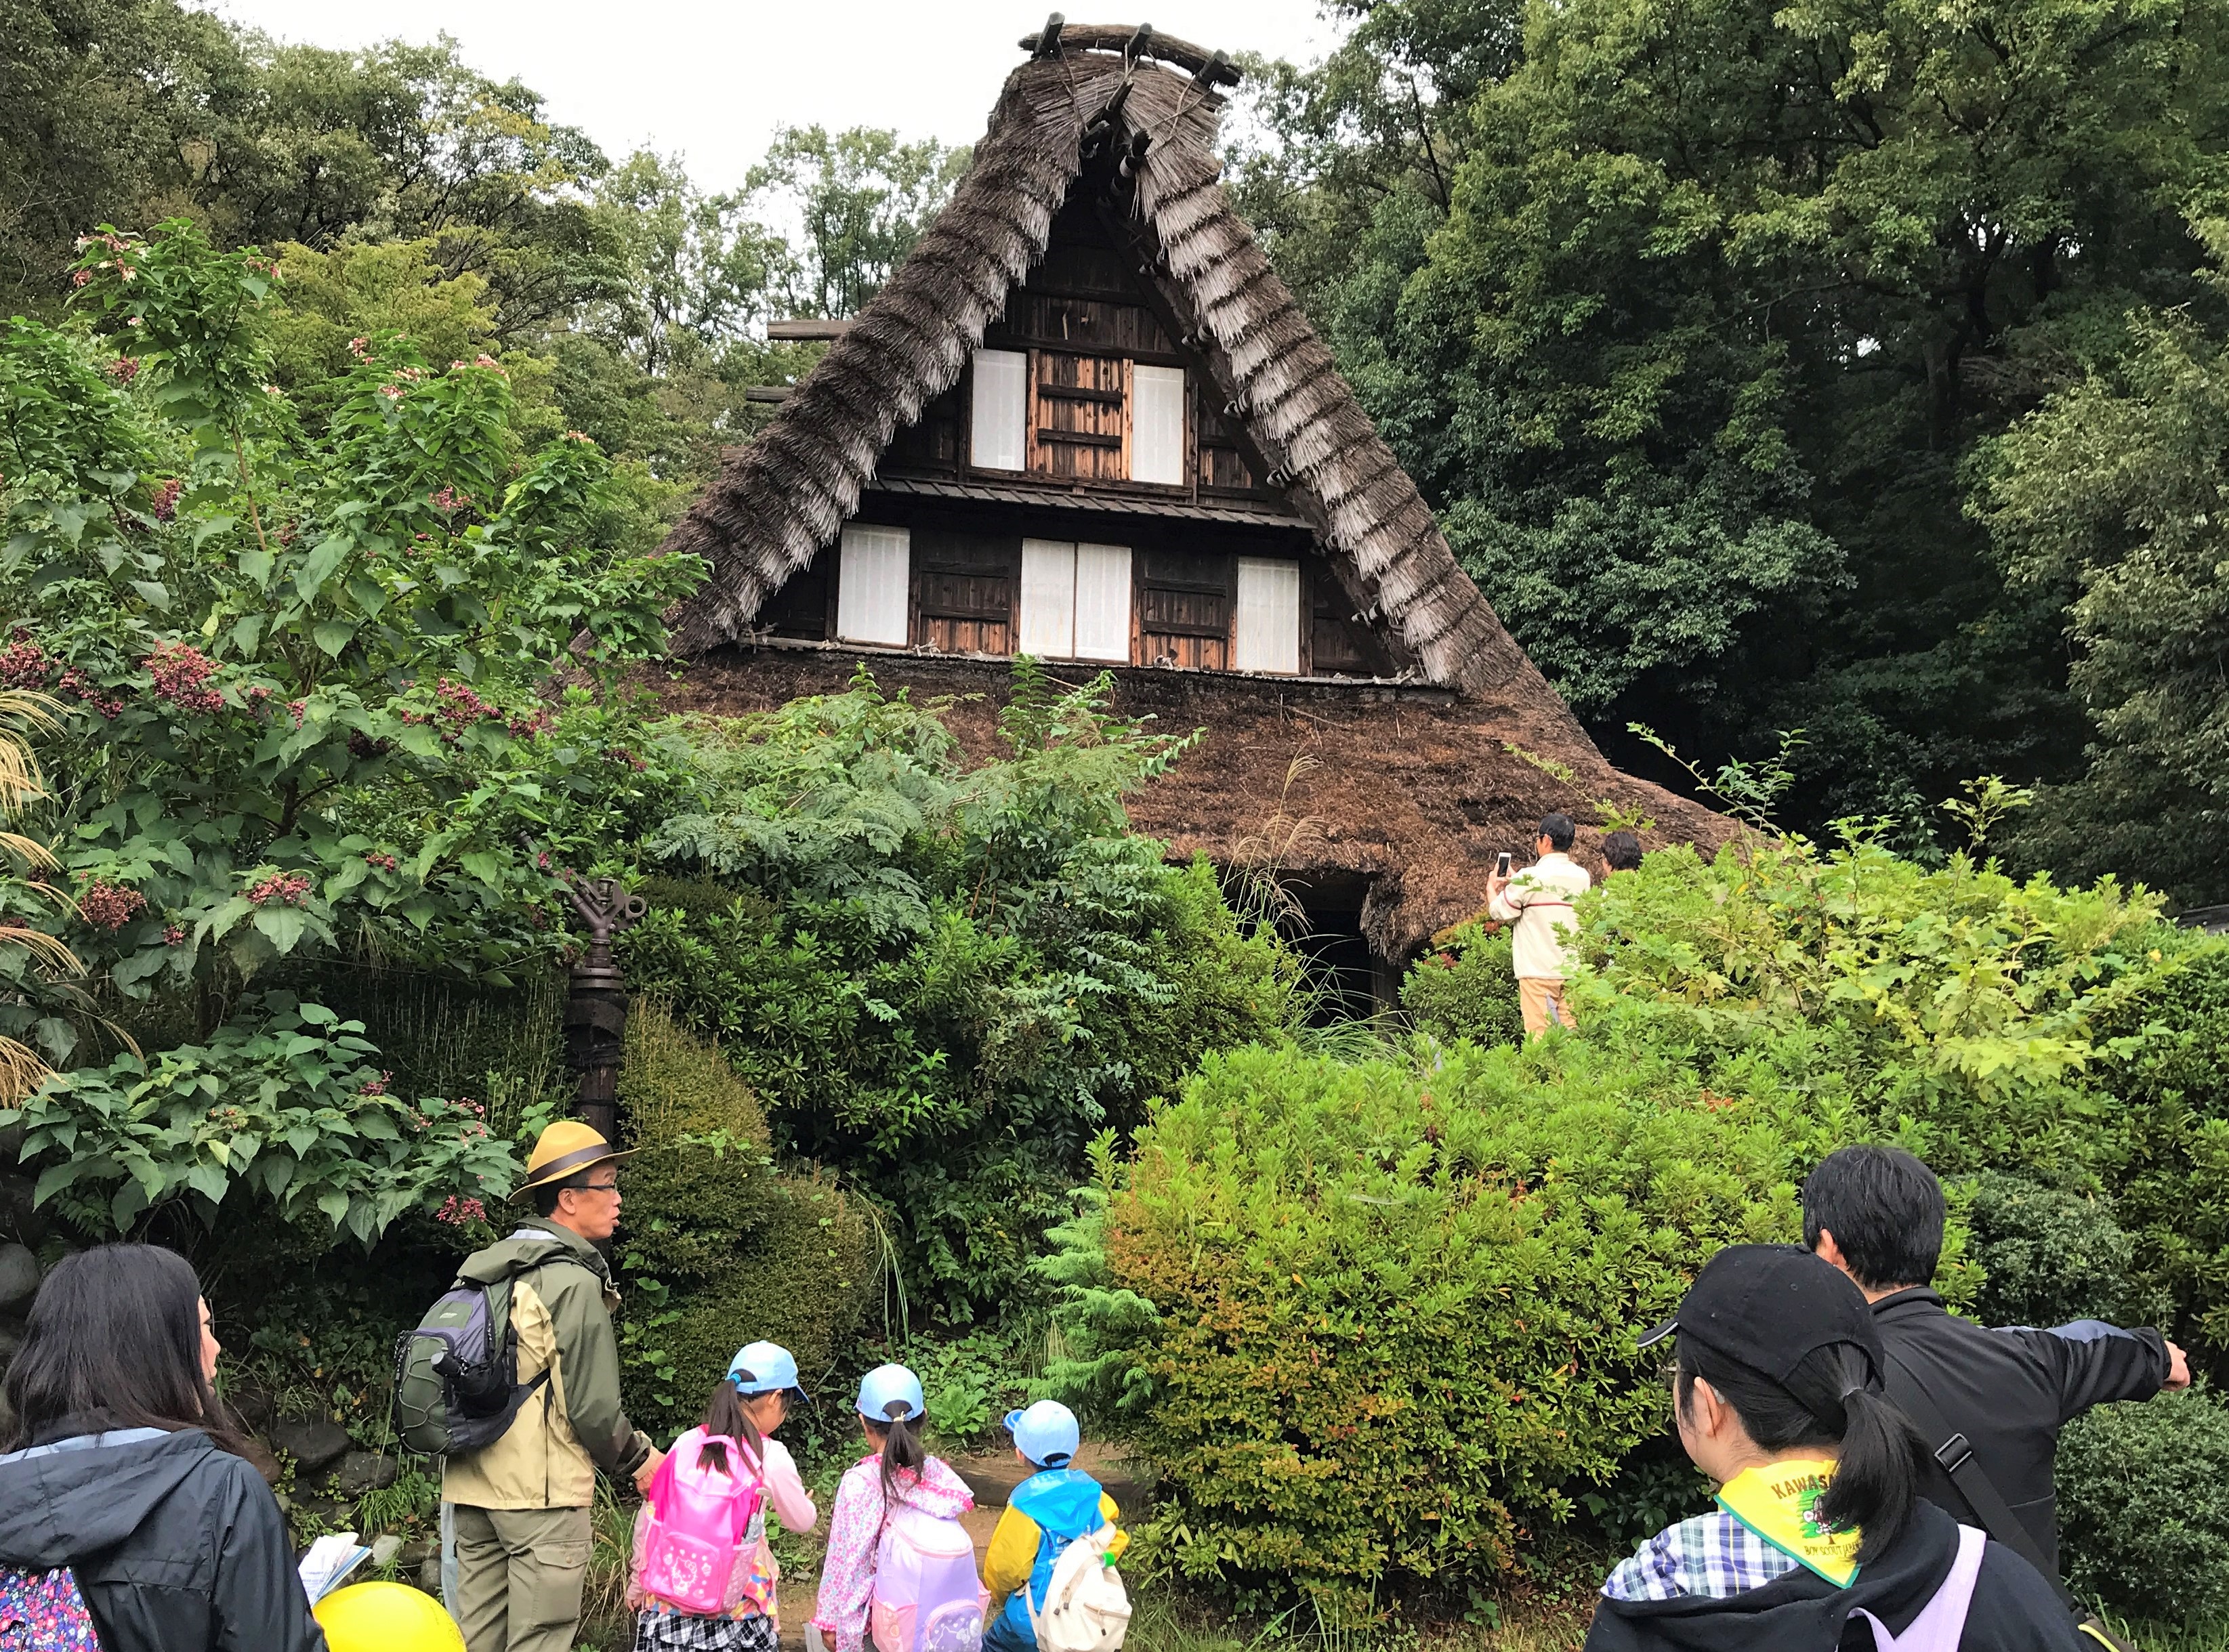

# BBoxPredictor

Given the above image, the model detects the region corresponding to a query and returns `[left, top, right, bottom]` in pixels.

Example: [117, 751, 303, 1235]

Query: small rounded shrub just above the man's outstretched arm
[1966, 1170, 2160, 1324]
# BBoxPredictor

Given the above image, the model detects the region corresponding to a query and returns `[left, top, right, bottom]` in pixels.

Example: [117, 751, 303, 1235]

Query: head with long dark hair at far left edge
[0, 1244, 238, 1452]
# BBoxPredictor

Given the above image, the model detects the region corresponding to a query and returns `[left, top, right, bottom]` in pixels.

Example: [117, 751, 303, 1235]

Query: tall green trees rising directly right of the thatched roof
[1244, 0, 2229, 878]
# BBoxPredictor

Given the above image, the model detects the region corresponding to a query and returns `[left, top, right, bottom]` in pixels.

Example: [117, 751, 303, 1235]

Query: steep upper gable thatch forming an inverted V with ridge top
[667, 26, 1593, 727]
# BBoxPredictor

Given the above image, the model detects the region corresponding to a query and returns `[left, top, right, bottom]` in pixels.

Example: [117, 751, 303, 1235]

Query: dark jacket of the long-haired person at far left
[0, 1429, 325, 1652]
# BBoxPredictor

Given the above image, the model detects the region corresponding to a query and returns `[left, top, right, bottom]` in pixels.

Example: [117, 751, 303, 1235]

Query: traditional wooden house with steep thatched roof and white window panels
[650, 22, 1730, 994]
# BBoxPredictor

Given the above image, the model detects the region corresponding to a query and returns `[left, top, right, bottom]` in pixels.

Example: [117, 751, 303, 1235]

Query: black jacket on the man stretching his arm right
[1873, 1288, 2167, 1569]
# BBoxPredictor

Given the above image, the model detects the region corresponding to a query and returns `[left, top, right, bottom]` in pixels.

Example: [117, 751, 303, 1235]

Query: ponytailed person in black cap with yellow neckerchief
[1587, 1244, 2082, 1652]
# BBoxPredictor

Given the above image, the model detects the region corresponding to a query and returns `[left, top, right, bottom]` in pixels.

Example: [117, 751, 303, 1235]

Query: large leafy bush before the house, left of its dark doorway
[620, 662, 1297, 1320]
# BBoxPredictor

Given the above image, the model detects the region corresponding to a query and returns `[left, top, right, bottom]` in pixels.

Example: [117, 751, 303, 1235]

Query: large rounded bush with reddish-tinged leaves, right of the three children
[1052, 1046, 1797, 1609]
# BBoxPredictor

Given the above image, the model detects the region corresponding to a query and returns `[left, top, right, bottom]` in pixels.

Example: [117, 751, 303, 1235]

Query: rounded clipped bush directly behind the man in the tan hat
[620, 1001, 878, 1431]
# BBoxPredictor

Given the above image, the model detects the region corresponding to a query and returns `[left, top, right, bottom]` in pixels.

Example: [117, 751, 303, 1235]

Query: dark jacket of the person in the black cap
[1587, 1502, 2082, 1652]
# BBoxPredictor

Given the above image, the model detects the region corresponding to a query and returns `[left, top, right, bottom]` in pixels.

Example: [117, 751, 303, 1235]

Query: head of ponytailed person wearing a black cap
[1643, 1244, 1919, 1561]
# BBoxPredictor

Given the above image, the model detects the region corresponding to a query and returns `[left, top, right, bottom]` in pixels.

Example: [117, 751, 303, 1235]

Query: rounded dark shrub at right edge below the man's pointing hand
[2058, 1389, 2229, 1623]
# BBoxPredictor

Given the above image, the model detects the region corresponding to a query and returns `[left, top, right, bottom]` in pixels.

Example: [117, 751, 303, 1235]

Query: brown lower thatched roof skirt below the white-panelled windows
[660, 649, 1738, 961]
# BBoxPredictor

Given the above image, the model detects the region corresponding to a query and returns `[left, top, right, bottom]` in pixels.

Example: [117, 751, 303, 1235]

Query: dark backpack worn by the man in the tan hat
[394, 1246, 582, 1456]
